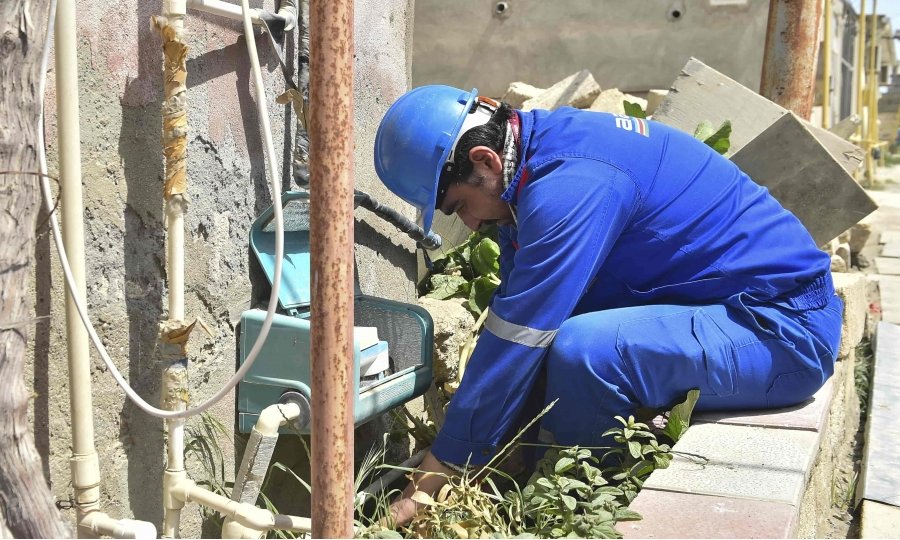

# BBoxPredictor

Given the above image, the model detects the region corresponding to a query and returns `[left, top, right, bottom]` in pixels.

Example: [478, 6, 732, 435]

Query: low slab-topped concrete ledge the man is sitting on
[616, 274, 864, 538]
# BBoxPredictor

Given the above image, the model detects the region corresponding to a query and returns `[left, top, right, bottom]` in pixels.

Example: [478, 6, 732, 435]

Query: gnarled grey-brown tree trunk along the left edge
[0, 0, 71, 538]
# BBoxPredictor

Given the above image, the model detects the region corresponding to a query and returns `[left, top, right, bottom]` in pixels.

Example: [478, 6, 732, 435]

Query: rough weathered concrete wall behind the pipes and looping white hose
[31, 0, 415, 537]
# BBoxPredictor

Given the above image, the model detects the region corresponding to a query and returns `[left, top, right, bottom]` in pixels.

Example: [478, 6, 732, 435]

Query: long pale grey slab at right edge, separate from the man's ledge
[860, 322, 900, 505]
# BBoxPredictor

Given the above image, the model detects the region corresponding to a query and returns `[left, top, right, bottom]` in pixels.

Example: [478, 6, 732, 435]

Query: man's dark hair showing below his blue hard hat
[435, 101, 515, 208]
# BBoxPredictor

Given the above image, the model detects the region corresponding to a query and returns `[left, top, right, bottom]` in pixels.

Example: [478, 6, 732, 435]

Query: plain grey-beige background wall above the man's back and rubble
[413, 0, 769, 96]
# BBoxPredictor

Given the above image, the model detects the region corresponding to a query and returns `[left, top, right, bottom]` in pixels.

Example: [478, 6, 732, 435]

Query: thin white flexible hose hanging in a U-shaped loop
[37, 0, 284, 418]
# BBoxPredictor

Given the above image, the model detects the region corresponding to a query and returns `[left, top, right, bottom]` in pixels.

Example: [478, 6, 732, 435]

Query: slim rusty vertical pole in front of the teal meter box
[309, 0, 354, 538]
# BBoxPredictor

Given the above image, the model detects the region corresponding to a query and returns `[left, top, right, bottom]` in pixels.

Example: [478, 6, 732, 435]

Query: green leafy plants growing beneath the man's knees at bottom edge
[362, 390, 699, 538]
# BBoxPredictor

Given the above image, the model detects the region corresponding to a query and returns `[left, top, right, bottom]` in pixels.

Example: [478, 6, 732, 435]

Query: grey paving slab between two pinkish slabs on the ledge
[644, 424, 819, 507]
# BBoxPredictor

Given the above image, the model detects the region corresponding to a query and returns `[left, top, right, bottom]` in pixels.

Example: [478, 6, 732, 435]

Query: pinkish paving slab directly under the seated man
[693, 377, 834, 432]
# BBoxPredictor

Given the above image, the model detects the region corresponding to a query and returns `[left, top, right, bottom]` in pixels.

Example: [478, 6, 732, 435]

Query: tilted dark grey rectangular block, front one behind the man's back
[732, 112, 876, 245]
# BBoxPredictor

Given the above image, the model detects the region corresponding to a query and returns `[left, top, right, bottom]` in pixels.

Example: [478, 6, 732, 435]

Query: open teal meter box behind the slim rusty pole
[238, 191, 434, 433]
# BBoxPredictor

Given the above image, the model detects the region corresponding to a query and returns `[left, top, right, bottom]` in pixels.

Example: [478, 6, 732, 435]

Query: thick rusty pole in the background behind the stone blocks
[759, 0, 822, 120]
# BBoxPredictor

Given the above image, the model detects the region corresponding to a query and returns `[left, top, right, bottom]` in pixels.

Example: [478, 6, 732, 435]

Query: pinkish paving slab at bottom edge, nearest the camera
[616, 489, 797, 538]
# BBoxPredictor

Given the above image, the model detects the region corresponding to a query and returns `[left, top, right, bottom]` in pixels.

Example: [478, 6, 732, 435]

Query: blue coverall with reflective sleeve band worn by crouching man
[432, 108, 842, 465]
